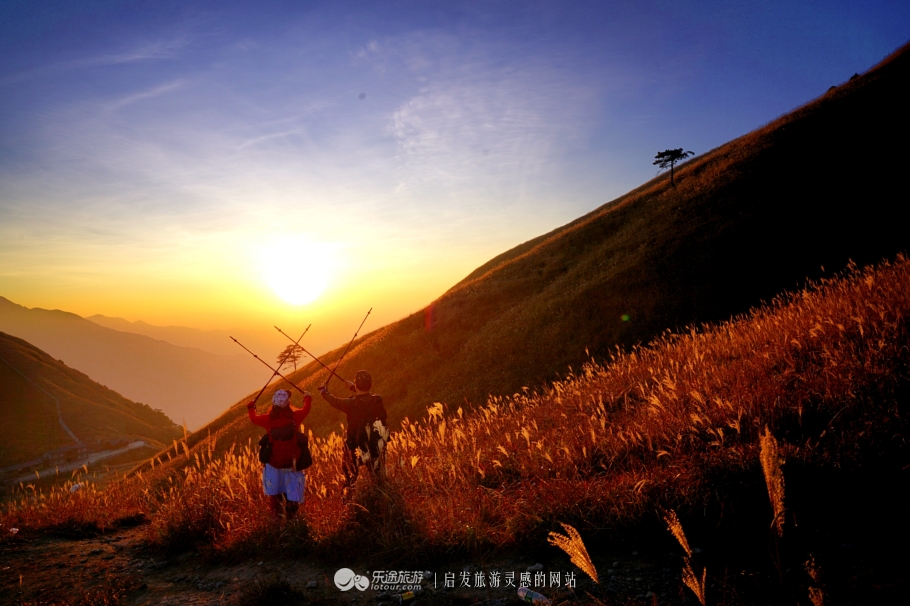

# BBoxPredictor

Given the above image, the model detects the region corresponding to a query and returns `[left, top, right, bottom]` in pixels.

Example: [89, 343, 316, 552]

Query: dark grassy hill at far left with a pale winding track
[0, 333, 183, 466]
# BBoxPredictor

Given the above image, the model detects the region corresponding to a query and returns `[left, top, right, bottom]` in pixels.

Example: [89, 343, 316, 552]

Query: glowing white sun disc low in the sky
[259, 236, 336, 305]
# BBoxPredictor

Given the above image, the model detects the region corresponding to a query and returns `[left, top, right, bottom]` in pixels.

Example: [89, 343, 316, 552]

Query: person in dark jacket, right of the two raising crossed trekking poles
[319, 370, 389, 488]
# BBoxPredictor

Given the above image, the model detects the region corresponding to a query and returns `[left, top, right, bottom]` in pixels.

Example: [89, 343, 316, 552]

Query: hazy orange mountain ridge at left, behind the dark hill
[0, 297, 270, 429]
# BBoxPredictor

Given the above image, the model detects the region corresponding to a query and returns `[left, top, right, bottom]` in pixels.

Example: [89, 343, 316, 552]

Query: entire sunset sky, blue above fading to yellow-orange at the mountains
[0, 0, 910, 356]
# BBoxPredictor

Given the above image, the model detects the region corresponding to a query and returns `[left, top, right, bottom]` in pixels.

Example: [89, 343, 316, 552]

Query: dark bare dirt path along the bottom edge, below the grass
[0, 526, 681, 606]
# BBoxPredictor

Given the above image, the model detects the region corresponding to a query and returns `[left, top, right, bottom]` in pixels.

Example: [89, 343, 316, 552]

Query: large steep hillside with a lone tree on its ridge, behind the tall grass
[187, 41, 910, 452]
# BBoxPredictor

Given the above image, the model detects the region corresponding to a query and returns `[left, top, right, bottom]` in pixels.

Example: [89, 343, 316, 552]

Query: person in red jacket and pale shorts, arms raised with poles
[246, 389, 313, 520]
